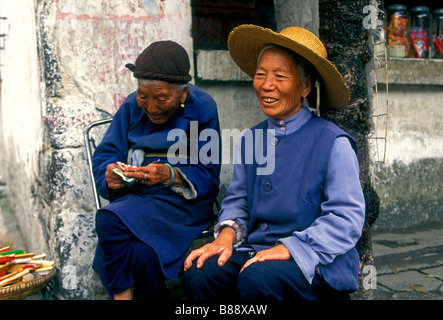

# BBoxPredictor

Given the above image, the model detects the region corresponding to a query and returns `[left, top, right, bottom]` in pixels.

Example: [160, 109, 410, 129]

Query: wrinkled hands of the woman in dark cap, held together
[105, 162, 171, 189]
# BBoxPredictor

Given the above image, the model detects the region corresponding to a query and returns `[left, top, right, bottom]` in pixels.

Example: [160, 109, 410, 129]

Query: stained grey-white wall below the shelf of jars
[373, 81, 443, 231]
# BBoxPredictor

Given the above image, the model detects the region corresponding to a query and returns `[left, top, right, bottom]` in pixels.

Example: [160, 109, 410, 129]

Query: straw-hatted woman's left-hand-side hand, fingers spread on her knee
[184, 227, 235, 271]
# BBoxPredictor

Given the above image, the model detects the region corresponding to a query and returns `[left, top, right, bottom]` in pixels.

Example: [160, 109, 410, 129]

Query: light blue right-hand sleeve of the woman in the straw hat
[279, 137, 365, 283]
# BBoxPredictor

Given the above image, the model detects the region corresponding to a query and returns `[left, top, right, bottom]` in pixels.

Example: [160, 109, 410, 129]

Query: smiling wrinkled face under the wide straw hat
[253, 48, 311, 120]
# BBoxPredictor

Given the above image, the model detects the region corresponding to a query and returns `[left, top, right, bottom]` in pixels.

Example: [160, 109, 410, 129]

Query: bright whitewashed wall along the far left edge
[0, 0, 48, 258]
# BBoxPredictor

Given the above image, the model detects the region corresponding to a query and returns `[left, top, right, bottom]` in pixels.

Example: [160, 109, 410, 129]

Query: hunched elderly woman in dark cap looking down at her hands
[93, 41, 220, 299]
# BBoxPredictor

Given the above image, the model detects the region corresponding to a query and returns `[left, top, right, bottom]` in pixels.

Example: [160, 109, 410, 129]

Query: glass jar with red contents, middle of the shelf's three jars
[409, 6, 432, 58]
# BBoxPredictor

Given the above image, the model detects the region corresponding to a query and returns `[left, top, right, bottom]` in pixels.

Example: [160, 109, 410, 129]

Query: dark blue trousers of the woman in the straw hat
[182, 251, 349, 300]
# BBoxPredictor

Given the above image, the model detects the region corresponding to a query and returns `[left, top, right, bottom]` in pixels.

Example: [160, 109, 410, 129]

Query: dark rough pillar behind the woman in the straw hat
[319, 0, 379, 299]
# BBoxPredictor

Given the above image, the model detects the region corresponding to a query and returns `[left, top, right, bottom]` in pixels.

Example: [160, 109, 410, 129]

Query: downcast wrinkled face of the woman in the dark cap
[137, 81, 188, 124]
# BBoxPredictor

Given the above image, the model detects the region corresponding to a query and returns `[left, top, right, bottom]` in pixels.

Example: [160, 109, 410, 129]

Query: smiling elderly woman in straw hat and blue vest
[183, 25, 365, 299]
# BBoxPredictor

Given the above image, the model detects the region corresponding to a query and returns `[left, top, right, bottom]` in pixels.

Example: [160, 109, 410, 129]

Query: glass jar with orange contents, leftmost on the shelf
[386, 4, 409, 58]
